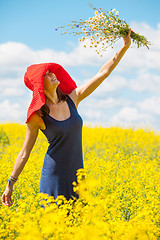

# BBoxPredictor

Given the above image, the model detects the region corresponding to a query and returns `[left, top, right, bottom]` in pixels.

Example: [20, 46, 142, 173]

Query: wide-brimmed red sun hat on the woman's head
[24, 63, 77, 123]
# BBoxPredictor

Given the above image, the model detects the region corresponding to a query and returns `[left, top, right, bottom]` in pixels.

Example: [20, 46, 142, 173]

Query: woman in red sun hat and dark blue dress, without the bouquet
[2, 29, 131, 207]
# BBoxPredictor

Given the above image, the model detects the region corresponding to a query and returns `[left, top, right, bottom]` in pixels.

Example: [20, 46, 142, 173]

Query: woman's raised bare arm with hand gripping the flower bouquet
[70, 29, 131, 105]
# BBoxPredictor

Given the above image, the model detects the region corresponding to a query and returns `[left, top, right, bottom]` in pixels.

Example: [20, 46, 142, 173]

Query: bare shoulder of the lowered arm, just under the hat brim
[27, 113, 46, 130]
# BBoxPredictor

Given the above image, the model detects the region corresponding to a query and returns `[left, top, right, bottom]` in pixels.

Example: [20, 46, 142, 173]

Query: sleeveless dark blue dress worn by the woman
[40, 96, 83, 200]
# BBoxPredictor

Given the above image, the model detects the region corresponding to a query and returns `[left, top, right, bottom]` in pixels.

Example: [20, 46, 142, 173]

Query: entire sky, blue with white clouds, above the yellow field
[0, 0, 160, 130]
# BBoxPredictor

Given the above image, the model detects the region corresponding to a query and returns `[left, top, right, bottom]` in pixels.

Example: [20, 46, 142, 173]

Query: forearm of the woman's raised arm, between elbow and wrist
[100, 45, 129, 78]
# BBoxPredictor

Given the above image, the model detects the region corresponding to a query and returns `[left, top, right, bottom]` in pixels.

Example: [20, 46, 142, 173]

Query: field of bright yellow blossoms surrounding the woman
[0, 123, 160, 240]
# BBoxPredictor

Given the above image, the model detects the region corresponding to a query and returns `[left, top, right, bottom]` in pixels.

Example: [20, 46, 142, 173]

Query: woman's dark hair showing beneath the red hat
[37, 87, 68, 117]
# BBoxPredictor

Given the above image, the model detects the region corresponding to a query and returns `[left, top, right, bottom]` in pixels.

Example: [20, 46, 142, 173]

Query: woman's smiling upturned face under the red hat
[43, 70, 60, 90]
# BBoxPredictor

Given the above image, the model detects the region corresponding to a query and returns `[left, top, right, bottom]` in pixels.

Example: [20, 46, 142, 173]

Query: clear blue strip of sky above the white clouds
[0, 0, 160, 50]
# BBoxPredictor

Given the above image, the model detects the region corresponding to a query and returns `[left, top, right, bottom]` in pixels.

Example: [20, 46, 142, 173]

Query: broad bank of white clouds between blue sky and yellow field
[0, 22, 160, 131]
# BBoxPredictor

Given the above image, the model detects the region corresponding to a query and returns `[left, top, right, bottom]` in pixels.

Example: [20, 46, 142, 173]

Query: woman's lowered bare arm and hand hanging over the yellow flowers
[1, 113, 42, 207]
